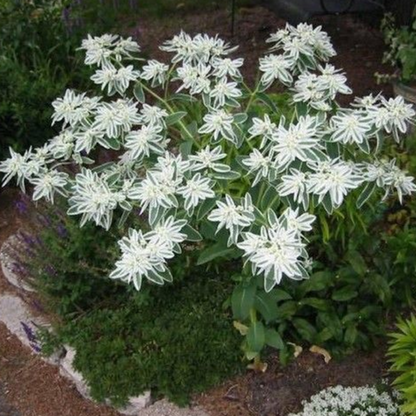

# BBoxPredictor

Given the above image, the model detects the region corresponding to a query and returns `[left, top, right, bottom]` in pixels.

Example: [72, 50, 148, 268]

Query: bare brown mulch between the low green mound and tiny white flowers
[199, 346, 386, 416]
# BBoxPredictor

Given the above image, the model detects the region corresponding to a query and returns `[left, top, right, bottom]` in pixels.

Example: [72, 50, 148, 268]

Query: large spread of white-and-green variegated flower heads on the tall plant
[0, 24, 416, 291]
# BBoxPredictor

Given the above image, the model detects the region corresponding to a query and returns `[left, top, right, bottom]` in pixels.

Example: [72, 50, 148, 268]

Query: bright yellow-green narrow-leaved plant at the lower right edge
[388, 315, 416, 416]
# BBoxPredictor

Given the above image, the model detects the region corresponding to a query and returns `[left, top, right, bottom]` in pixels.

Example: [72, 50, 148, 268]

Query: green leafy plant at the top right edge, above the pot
[380, 7, 416, 84]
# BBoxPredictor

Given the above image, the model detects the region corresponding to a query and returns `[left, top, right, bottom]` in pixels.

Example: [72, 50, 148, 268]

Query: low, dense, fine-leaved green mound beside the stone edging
[60, 274, 242, 404]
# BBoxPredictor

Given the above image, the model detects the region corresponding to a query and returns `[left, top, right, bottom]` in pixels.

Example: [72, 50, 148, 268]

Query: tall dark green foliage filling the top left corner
[0, 0, 88, 156]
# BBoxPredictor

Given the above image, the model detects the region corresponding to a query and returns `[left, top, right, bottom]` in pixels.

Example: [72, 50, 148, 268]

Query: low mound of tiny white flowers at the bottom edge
[289, 386, 401, 416]
